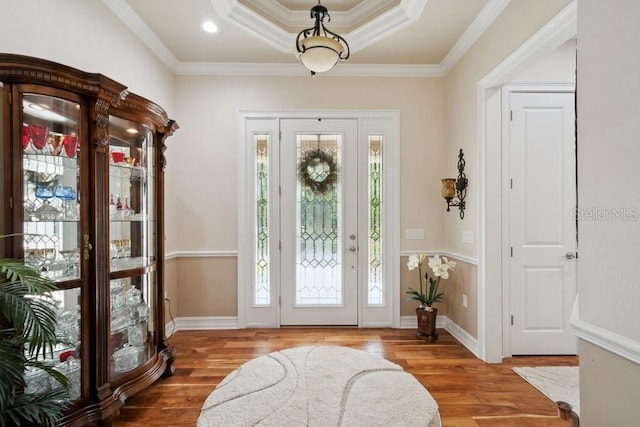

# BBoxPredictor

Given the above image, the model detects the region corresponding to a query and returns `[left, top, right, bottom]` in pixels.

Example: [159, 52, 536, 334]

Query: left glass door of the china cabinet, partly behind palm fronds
[20, 93, 82, 400]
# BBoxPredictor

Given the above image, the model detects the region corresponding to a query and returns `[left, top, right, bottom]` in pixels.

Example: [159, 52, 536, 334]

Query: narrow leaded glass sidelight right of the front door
[367, 135, 384, 305]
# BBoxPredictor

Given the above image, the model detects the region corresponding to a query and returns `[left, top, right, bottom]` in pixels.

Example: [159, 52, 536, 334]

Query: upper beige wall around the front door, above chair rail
[170, 76, 445, 251]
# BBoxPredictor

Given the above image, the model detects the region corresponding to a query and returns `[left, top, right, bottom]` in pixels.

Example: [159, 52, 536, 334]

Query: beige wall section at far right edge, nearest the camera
[577, 0, 640, 427]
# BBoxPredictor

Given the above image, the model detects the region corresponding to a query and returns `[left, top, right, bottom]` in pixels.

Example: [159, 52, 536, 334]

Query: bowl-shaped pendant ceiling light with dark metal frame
[296, 0, 349, 76]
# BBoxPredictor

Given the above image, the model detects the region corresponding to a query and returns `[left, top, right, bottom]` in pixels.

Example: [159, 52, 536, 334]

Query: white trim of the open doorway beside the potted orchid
[477, 0, 578, 363]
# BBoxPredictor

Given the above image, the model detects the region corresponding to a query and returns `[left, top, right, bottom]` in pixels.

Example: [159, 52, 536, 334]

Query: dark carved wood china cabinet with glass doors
[0, 54, 178, 426]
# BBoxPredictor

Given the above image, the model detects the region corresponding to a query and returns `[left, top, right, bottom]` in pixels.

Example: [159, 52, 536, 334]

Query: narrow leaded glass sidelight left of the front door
[253, 134, 271, 306]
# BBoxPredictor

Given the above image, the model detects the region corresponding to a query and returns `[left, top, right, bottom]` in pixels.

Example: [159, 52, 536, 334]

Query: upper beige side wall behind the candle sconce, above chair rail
[444, 0, 570, 257]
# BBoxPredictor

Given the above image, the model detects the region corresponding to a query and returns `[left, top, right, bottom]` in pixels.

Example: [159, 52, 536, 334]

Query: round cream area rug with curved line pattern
[197, 346, 441, 427]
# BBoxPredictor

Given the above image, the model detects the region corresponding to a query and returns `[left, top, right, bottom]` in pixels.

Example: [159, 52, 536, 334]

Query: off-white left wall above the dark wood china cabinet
[0, 0, 180, 251]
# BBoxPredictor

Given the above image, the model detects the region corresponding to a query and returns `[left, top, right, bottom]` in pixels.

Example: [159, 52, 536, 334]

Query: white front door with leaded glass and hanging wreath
[280, 119, 359, 325]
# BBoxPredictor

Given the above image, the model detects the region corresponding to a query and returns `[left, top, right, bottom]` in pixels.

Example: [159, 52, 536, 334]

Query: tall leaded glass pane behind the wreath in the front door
[295, 134, 343, 306]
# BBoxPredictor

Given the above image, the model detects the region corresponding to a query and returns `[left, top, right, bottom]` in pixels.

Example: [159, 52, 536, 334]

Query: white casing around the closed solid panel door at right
[501, 82, 578, 357]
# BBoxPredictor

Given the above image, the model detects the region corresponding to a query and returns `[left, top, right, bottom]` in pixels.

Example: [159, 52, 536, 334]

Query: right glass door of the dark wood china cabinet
[109, 116, 157, 375]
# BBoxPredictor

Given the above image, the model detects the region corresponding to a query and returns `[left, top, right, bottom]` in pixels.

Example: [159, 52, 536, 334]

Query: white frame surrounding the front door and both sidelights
[237, 110, 401, 328]
